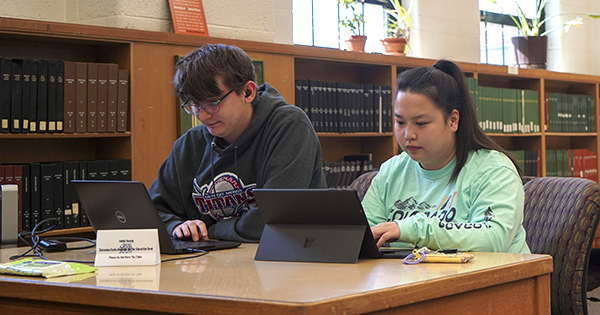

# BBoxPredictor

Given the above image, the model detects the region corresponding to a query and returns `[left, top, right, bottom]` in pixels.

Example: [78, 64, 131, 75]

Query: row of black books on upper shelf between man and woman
[295, 79, 392, 133]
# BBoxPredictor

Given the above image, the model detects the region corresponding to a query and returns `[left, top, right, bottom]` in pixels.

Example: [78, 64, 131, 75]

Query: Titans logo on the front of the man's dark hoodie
[192, 172, 256, 220]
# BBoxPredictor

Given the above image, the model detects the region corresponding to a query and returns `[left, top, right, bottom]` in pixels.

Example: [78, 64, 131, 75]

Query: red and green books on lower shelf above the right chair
[546, 149, 598, 182]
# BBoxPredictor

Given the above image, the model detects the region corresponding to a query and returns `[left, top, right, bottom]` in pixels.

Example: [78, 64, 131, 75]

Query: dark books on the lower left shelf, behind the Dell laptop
[0, 159, 131, 231]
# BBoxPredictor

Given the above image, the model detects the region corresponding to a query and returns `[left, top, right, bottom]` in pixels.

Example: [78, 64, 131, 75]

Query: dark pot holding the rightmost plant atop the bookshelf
[510, 36, 548, 69]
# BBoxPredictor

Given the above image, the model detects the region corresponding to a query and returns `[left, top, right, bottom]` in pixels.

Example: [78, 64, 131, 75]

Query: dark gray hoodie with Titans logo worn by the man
[149, 83, 326, 242]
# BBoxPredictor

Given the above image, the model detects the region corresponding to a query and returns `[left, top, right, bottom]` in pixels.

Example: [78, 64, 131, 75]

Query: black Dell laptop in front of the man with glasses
[71, 180, 241, 254]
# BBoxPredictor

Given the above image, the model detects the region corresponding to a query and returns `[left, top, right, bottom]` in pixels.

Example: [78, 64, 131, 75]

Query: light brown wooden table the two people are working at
[0, 244, 552, 315]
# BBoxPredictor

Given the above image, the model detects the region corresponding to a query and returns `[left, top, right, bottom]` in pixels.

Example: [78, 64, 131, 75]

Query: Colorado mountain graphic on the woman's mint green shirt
[388, 192, 494, 230]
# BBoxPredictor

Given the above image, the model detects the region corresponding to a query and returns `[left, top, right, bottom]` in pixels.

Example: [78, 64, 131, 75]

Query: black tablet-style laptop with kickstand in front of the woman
[254, 189, 412, 263]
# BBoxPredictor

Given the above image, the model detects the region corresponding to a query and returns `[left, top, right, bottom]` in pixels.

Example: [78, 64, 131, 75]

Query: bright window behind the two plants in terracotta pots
[292, 0, 388, 53]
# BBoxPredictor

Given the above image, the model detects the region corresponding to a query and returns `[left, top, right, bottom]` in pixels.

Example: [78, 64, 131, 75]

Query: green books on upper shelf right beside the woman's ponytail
[467, 78, 540, 133]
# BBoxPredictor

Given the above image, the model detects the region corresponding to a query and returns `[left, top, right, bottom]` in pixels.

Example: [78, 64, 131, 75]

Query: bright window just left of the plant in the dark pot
[479, 0, 536, 66]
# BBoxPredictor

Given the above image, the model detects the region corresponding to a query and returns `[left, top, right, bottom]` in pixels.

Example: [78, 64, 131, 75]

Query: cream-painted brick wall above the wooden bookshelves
[0, 0, 600, 75]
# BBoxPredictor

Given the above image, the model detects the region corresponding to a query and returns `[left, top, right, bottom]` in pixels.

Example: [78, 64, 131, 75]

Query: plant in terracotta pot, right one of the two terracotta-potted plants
[381, 0, 414, 55]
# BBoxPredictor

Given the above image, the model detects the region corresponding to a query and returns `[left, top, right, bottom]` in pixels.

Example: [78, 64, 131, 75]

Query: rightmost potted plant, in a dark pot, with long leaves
[488, 0, 600, 69]
